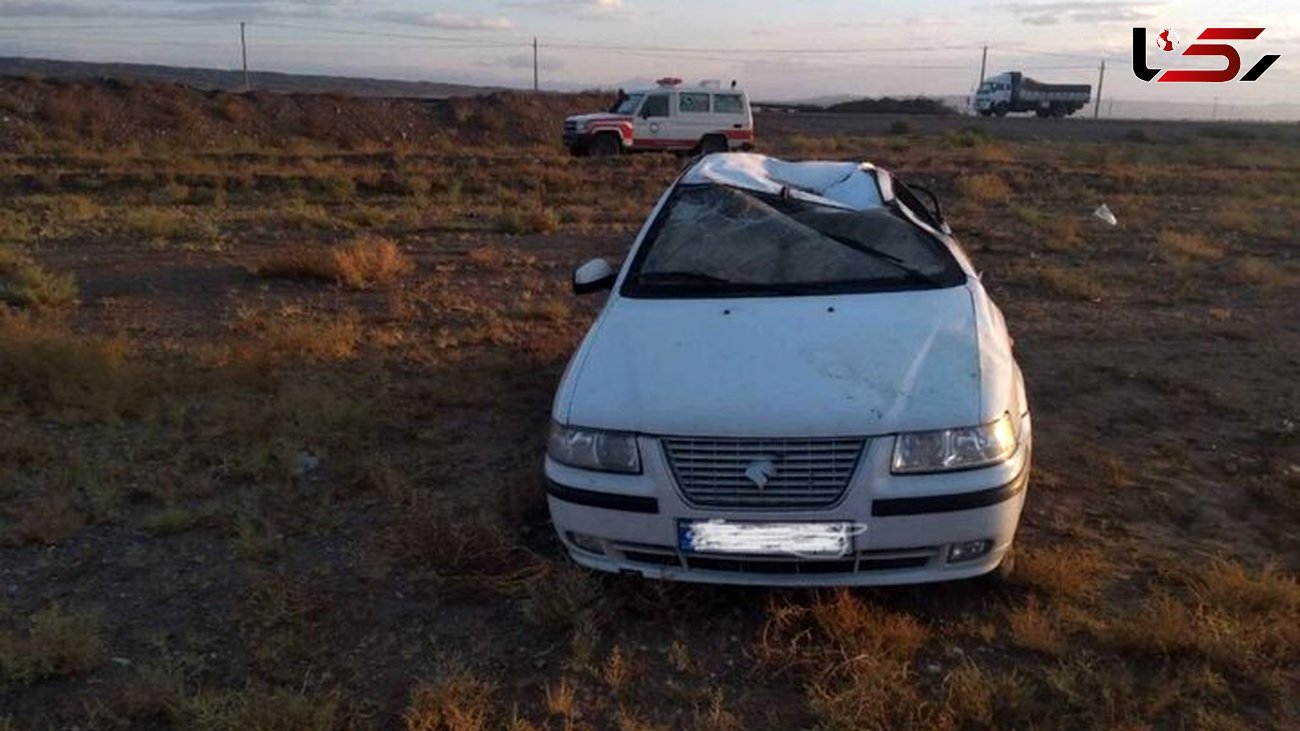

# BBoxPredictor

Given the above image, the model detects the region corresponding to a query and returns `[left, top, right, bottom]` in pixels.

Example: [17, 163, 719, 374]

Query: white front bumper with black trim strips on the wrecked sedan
[546, 415, 1031, 587]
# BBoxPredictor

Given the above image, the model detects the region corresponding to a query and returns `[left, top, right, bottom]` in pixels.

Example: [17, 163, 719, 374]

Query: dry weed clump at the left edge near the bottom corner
[0, 605, 105, 683]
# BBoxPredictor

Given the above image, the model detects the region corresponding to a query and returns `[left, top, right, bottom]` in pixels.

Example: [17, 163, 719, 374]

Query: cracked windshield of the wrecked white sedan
[623, 185, 966, 298]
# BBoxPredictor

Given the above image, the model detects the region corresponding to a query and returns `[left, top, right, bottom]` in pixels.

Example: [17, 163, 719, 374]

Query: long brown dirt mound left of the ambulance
[0, 77, 610, 153]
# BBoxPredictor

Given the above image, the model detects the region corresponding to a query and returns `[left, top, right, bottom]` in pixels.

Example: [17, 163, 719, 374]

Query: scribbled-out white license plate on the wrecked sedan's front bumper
[677, 520, 863, 558]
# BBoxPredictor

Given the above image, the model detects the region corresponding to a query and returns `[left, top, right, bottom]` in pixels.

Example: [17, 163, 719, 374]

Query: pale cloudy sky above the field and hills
[0, 0, 1300, 105]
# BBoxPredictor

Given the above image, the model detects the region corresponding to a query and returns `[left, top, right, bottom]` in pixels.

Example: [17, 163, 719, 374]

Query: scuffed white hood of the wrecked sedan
[555, 286, 982, 437]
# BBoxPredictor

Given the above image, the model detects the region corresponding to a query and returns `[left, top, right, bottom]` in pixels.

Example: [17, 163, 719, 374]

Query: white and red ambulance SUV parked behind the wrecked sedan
[564, 78, 754, 157]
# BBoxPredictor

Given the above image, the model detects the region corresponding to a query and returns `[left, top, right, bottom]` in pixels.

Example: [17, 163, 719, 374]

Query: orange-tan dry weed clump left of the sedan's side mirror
[257, 234, 415, 289]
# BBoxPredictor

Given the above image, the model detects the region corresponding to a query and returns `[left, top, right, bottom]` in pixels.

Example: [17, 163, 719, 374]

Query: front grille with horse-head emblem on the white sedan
[663, 437, 866, 509]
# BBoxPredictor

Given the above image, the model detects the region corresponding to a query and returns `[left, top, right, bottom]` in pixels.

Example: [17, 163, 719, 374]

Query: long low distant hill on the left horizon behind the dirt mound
[0, 57, 501, 99]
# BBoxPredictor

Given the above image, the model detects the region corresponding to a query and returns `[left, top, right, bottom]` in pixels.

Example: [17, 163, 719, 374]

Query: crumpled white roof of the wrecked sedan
[681, 152, 884, 211]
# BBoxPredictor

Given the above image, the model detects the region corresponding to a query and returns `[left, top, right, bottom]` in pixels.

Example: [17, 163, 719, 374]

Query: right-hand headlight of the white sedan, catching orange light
[891, 414, 1017, 475]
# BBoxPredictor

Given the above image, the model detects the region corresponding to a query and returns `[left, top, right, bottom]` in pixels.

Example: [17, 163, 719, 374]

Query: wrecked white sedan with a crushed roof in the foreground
[545, 153, 1031, 585]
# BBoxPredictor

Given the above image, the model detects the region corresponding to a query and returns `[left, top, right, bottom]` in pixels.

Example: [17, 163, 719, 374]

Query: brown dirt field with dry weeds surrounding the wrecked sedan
[0, 76, 1300, 731]
